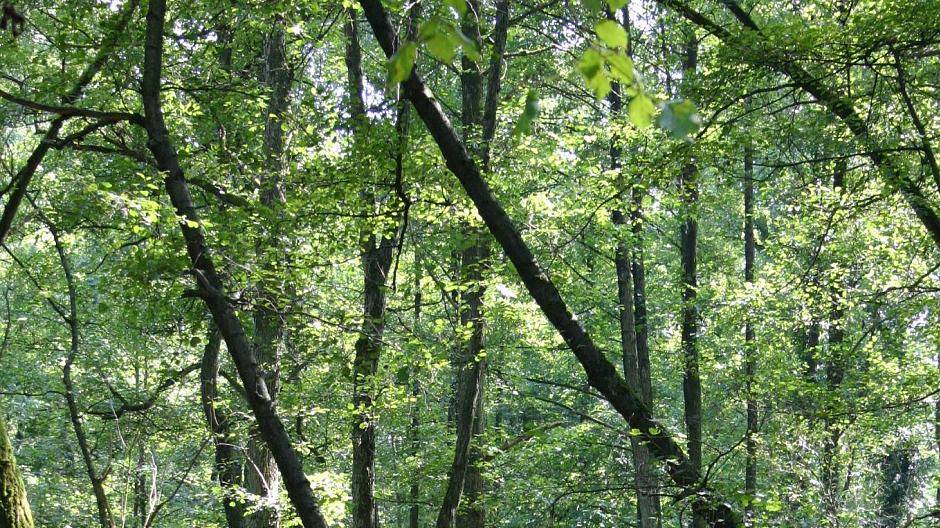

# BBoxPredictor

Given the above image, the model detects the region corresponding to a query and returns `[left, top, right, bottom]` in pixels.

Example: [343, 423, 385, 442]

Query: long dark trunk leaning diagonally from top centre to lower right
[359, 0, 741, 527]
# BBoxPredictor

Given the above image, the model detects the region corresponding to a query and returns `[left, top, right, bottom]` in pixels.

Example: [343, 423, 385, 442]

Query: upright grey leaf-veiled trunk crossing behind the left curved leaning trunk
[245, 17, 292, 528]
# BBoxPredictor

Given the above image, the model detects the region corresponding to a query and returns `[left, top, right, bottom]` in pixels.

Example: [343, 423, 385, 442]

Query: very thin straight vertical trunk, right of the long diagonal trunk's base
[744, 140, 757, 525]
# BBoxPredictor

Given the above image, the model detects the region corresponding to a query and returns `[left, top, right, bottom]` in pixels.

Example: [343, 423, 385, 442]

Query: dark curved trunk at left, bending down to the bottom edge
[142, 0, 326, 528]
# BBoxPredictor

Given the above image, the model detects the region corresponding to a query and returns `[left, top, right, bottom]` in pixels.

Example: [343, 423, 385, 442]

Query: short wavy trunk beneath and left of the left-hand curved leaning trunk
[199, 328, 244, 528]
